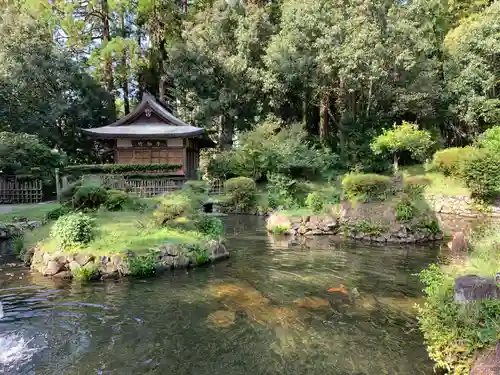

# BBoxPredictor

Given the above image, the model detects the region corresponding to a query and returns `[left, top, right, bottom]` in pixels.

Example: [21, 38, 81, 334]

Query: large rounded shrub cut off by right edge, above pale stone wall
[461, 149, 500, 201]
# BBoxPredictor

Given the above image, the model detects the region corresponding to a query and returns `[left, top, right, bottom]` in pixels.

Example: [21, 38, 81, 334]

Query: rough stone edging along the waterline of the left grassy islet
[29, 241, 229, 280]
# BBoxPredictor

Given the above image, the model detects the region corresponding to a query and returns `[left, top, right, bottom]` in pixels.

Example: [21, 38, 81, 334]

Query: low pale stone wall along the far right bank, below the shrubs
[425, 195, 500, 218]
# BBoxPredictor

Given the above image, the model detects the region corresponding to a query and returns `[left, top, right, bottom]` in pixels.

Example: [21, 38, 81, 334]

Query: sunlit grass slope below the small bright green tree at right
[401, 165, 470, 197]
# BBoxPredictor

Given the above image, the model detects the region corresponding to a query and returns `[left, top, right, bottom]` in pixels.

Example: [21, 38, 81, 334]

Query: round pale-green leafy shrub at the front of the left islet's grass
[50, 212, 95, 249]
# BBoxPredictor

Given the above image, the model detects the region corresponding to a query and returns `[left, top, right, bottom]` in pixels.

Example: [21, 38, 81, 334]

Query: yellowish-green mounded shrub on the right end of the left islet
[153, 193, 198, 225]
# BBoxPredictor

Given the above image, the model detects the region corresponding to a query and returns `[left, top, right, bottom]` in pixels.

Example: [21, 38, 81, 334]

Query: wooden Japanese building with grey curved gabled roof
[83, 93, 214, 179]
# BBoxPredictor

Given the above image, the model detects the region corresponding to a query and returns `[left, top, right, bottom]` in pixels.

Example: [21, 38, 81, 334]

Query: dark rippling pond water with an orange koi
[0, 216, 439, 375]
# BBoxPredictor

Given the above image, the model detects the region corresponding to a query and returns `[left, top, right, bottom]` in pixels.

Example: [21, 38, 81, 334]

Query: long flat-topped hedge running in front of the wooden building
[62, 164, 182, 175]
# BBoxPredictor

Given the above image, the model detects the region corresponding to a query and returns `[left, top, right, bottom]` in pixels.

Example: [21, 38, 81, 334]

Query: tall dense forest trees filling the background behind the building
[0, 0, 500, 170]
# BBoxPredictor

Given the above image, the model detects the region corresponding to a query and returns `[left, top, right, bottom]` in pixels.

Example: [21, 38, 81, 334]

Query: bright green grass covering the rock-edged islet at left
[25, 211, 205, 255]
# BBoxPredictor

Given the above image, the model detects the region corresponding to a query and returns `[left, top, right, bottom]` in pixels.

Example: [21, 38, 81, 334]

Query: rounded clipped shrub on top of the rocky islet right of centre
[342, 173, 392, 201]
